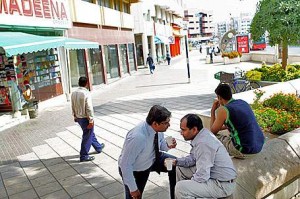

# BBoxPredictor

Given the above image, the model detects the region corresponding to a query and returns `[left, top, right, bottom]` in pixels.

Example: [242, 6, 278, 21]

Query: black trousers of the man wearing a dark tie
[119, 153, 176, 199]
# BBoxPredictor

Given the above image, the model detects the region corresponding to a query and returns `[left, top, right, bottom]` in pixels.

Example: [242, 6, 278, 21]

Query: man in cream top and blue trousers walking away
[71, 77, 104, 162]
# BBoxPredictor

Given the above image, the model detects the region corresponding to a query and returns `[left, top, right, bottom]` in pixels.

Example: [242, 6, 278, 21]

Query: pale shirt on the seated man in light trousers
[177, 128, 237, 182]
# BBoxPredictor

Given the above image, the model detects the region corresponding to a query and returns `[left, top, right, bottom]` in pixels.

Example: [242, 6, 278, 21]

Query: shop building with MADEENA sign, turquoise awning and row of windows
[0, 0, 138, 111]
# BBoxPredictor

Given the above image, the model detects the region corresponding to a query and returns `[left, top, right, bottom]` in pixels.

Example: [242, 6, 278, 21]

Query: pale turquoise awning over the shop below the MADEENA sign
[0, 32, 99, 57]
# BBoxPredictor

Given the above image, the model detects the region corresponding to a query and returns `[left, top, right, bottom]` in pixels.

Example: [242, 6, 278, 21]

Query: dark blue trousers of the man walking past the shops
[77, 118, 102, 160]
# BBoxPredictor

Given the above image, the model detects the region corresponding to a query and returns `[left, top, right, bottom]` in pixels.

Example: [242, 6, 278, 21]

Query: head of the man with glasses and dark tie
[146, 105, 171, 132]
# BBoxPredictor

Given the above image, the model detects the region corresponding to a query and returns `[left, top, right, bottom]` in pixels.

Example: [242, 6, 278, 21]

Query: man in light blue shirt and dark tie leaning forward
[118, 105, 177, 199]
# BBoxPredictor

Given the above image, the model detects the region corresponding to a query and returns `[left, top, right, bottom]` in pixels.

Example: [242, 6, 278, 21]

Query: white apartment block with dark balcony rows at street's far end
[184, 8, 215, 41]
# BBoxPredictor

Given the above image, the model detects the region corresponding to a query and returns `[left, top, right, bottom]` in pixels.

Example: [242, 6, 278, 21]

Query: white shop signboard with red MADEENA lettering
[0, 0, 72, 29]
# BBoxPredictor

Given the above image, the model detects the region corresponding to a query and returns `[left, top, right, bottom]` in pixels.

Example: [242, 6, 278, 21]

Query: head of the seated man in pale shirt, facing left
[180, 114, 203, 141]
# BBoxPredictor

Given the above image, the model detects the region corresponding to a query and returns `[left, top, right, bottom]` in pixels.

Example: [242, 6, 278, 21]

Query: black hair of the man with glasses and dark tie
[146, 105, 171, 125]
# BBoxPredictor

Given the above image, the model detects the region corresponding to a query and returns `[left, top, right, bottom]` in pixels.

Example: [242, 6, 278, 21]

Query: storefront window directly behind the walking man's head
[69, 49, 86, 87]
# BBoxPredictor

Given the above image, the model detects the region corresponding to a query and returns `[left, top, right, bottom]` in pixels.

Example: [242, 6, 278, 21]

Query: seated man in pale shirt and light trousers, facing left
[175, 114, 237, 199]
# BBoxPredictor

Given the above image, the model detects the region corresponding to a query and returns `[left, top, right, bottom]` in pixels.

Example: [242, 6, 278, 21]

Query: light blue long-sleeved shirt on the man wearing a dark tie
[118, 121, 169, 191]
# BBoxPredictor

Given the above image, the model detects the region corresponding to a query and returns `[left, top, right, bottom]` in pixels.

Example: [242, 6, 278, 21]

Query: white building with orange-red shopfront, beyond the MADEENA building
[131, 0, 184, 66]
